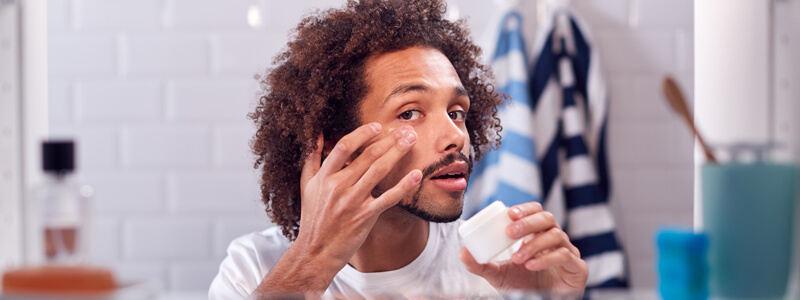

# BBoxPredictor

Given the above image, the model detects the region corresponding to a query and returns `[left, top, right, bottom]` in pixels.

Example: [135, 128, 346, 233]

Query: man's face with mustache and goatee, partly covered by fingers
[360, 47, 472, 222]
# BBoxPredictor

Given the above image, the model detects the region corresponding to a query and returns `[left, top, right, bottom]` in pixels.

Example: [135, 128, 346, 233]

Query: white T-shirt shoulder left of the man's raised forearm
[209, 226, 291, 299]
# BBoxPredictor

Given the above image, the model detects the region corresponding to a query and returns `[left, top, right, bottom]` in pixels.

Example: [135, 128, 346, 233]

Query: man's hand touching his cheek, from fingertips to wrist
[297, 123, 422, 267]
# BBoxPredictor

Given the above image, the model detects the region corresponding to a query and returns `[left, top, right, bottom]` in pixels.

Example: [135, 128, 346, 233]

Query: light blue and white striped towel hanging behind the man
[464, 11, 541, 217]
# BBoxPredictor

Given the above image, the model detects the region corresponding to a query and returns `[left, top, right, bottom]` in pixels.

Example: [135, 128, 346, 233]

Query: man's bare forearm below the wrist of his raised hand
[253, 240, 347, 299]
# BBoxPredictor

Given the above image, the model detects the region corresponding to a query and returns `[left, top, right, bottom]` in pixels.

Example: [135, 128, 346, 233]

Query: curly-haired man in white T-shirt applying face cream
[209, 0, 588, 298]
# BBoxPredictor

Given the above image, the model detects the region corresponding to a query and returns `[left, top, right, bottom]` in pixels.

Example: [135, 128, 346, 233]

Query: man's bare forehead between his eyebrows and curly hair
[365, 47, 461, 94]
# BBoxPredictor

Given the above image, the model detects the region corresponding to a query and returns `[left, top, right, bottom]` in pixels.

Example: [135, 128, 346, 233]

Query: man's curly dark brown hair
[249, 0, 504, 240]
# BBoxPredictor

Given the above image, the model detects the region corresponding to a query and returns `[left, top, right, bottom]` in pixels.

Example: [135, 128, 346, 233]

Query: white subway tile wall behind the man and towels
[48, 0, 694, 292]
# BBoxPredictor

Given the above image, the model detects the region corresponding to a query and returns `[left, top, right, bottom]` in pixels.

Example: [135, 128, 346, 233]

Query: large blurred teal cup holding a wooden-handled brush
[702, 163, 797, 299]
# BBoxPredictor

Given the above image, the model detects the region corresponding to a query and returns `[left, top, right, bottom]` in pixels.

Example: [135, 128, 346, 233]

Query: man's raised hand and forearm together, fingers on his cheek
[256, 123, 422, 293]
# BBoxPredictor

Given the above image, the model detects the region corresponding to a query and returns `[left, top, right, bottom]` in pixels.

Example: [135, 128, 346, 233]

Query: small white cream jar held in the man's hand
[458, 201, 517, 264]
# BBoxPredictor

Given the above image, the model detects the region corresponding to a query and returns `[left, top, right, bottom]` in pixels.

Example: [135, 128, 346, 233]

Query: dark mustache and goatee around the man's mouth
[396, 152, 472, 223]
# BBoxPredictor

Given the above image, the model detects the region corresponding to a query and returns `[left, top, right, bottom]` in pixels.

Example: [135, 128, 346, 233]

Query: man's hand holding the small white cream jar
[461, 202, 589, 293]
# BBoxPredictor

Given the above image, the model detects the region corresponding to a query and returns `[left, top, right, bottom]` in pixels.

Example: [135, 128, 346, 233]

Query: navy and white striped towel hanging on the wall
[530, 11, 627, 288]
